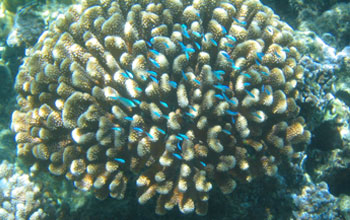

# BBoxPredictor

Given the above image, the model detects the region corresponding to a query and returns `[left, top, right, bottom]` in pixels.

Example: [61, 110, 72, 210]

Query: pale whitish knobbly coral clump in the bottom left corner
[0, 161, 55, 220]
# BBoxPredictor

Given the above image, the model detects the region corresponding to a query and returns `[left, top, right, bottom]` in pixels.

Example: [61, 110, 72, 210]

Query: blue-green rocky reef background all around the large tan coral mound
[0, 0, 350, 220]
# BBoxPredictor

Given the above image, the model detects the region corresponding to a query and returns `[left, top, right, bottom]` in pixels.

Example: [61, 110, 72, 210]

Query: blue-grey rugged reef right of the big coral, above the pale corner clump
[299, 42, 350, 193]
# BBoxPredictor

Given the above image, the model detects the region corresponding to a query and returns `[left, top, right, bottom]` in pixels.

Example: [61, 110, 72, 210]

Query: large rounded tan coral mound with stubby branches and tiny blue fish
[12, 0, 310, 215]
